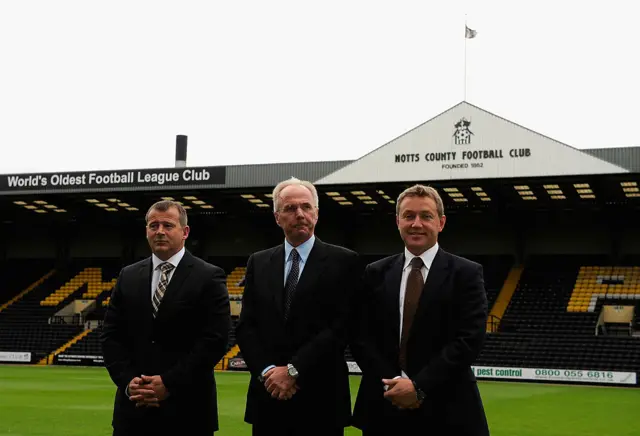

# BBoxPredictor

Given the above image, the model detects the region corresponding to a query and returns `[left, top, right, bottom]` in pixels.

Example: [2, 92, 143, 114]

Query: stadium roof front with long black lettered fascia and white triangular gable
[0, 102, 640, 195]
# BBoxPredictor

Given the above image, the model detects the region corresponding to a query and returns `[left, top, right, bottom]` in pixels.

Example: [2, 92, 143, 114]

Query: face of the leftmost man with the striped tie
[147, 207, 189, 260]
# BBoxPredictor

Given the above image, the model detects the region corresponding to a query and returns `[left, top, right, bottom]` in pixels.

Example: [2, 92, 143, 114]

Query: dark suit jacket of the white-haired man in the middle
[236, 237, 361, 428]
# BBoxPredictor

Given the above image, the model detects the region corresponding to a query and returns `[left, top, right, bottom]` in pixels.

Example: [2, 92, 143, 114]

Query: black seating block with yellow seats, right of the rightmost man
[476, 256, 640, 371]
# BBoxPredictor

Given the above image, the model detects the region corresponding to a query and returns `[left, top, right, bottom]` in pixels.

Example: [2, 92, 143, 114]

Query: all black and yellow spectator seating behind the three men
[0, 255, 640, 380]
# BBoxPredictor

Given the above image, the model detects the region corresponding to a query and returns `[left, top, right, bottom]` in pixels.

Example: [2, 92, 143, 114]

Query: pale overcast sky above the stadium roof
[0, 0, 640, 173]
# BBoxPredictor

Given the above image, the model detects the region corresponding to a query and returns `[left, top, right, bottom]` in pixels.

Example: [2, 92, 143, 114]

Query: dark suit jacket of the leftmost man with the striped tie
[101, 251, 230, 435]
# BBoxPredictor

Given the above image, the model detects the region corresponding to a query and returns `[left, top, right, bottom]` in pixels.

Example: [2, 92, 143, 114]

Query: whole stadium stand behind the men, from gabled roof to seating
[0, 102, 640, 385]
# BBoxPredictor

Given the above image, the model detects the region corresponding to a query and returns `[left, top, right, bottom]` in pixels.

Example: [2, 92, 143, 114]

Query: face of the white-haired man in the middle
[274, 185, 318, 246]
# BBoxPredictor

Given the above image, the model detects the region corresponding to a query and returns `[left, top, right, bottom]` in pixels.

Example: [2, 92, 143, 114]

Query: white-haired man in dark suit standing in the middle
[236, 179, 361, 436]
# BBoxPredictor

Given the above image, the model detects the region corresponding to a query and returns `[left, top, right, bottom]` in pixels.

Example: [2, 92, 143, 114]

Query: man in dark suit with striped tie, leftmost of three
[101, 201, 230, 436]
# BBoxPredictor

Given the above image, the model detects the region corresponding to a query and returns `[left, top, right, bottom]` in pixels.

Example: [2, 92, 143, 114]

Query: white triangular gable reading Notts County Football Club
[316, 102, 629, 184]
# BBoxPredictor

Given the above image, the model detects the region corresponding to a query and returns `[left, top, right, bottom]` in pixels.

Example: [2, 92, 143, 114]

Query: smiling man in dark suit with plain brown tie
[351, 185, 489, 436]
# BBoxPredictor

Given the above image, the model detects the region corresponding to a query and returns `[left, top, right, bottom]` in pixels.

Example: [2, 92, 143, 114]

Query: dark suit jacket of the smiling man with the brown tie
[351, 248, 489, 436]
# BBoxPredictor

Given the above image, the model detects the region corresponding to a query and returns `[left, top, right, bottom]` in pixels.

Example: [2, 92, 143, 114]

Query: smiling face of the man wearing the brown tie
[396, 197, 446, 256]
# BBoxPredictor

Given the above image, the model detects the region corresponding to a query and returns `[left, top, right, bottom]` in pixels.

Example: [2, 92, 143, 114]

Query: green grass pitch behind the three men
[0, 366, 640, 436]
